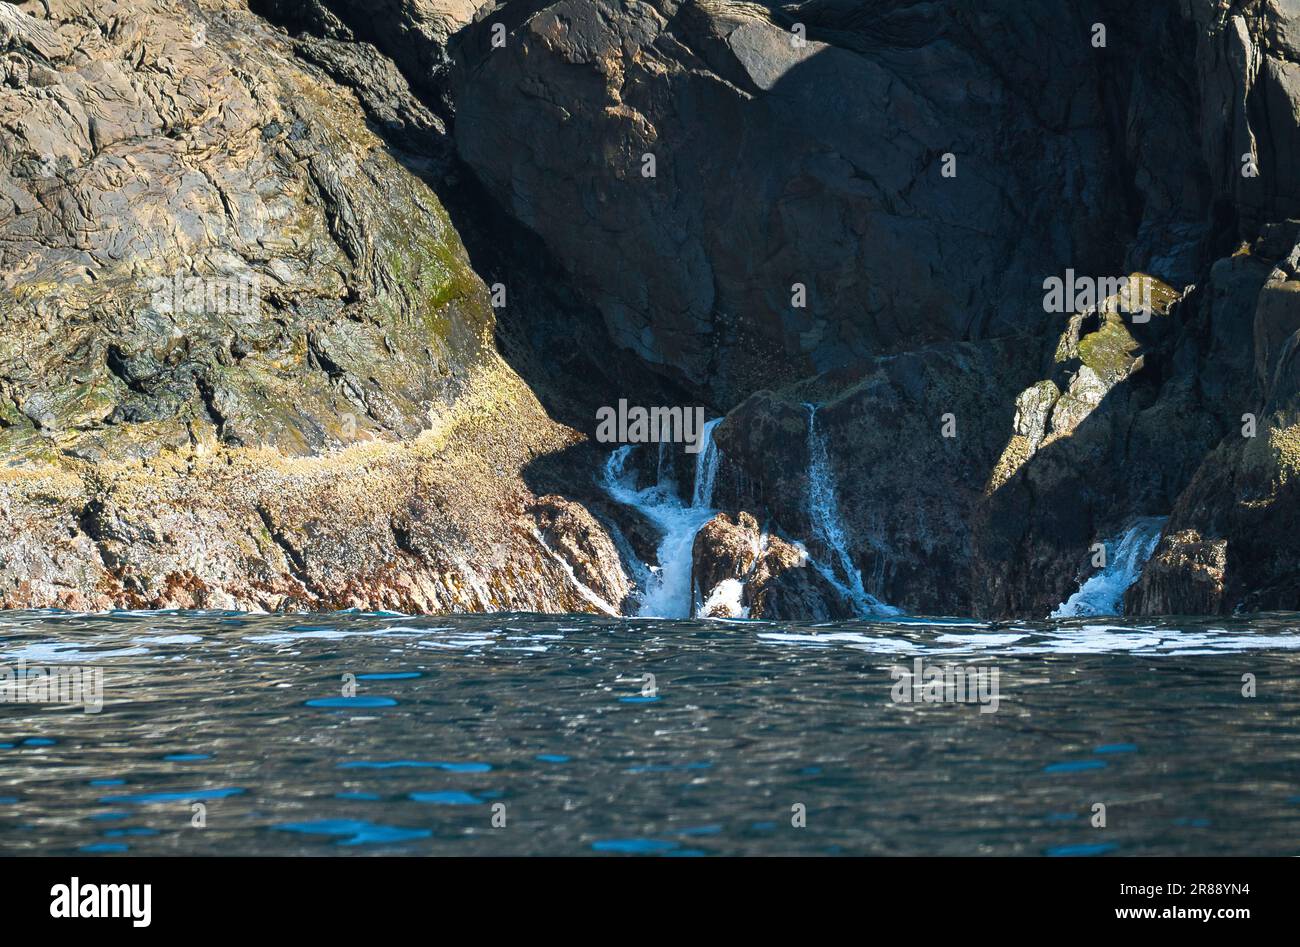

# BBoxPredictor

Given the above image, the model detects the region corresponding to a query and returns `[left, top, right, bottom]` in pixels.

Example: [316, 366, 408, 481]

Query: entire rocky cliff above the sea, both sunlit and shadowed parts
[0, 0, 1300, 619]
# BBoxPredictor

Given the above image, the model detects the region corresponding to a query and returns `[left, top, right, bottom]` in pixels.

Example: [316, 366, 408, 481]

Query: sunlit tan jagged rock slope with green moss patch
[0, 0, 625, 611]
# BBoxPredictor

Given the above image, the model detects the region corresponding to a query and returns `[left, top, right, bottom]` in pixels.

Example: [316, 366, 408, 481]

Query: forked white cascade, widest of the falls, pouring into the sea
[602, 418, 722, 618]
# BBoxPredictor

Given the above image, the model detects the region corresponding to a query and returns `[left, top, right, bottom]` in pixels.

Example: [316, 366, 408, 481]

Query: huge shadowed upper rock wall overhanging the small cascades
[456, 0, 1206, 403]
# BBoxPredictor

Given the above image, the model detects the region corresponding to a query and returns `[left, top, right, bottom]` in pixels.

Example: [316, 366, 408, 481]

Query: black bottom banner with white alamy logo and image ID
[0, 857, 1279, 938]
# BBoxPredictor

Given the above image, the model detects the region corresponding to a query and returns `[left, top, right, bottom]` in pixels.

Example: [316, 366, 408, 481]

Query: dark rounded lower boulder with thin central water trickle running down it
[715, 341, 1039, 614]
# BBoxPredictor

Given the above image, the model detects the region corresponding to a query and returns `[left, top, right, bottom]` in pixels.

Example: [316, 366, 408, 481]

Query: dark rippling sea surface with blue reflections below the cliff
[0, 611, 1300, 856]
